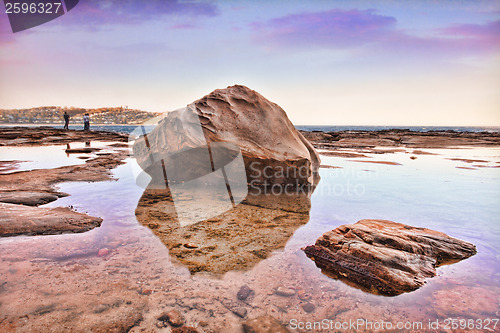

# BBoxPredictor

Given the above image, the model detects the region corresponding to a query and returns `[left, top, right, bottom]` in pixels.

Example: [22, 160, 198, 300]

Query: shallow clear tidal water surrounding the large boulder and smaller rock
[0, 144, 500, 332]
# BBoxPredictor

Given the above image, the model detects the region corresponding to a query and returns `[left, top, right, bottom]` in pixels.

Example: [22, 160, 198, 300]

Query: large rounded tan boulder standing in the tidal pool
[134, 85, 320, 186]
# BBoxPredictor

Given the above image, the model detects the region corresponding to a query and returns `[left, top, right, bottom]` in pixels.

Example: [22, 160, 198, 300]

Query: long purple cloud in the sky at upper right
[252, 9, 500, 58]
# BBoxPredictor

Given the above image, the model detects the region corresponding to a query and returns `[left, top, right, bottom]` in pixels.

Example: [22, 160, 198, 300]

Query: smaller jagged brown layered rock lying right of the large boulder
[304, 220, 476, 295]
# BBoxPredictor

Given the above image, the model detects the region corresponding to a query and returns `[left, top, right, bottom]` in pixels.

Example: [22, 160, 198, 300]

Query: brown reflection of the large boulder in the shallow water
[135, 189, 311, 276]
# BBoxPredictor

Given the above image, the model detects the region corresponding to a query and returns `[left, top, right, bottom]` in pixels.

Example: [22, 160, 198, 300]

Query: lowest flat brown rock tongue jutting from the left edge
[0, 203, 102, 237]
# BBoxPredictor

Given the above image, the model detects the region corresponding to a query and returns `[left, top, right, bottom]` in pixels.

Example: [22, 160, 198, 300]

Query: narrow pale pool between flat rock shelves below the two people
[0, 142, 124, 173]
